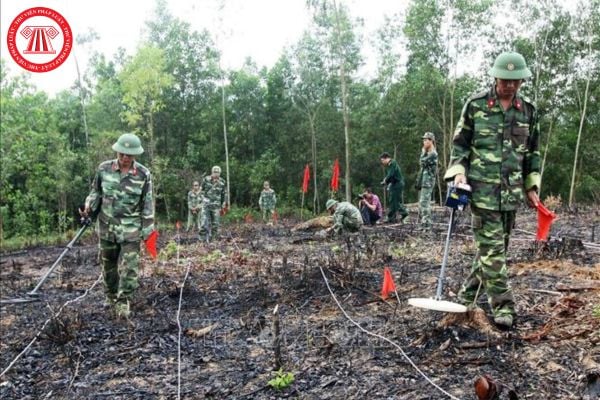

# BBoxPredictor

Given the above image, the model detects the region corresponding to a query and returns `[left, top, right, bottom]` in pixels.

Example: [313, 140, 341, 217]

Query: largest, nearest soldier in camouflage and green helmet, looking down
[444, 52, 541, 329]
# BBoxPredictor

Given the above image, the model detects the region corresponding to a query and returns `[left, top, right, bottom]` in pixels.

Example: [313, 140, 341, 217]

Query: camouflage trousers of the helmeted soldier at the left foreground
[100, 240, 140, 302]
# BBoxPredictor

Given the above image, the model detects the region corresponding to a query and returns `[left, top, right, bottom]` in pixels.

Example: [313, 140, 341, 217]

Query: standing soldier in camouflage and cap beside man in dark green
[415, 132, 437, 229]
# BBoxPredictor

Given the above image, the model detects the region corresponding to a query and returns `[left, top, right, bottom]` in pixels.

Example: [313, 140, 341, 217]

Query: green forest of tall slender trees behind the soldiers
[0, 0, 600, 247]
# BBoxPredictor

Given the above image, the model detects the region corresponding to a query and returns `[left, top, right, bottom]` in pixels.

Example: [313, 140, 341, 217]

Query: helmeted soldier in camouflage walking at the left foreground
[80, 133, 154, 318]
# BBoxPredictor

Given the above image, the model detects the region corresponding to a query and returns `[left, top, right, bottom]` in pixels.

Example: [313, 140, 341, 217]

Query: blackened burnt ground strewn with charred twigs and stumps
[0, 209, 600, 400]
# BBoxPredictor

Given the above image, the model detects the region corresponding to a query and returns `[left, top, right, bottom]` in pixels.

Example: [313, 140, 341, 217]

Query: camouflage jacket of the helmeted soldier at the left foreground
[85, 160, 154, 243]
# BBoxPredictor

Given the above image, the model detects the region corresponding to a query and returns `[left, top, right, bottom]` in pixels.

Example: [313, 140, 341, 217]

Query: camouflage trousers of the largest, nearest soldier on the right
[459, 206, 516, 317]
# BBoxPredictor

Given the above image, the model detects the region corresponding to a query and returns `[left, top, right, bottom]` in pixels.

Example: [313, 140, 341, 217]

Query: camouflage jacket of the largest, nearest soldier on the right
[444, 87, 541, 211]
